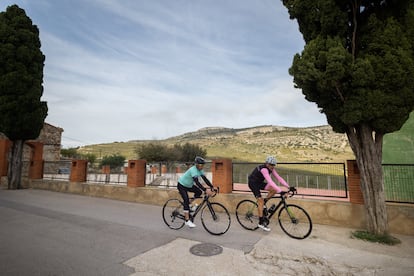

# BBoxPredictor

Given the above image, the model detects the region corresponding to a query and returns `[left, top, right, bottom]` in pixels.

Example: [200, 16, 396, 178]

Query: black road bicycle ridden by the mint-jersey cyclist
[162, 189, 231, 235]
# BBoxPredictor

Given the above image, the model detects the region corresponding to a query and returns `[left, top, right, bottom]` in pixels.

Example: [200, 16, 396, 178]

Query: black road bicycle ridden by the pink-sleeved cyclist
[236, 187, 312, 239]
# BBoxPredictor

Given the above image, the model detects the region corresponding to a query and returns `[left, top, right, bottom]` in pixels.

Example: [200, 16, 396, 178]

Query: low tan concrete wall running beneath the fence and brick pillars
[28, 179, 414, 235]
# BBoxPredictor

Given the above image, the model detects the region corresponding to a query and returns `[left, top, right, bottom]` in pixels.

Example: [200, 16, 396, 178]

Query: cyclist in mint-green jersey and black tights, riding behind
[177, 156, 213, 228]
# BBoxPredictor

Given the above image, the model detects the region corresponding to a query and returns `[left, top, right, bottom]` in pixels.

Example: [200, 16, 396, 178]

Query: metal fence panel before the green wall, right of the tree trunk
[382, 164, 414, 203]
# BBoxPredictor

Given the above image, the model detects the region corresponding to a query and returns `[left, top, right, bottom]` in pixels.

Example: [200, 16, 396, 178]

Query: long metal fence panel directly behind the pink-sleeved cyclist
[233, 163, 348, 198]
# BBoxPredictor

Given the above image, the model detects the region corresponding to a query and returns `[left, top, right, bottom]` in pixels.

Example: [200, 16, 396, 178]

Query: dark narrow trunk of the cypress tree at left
[7, 140, 24, 189]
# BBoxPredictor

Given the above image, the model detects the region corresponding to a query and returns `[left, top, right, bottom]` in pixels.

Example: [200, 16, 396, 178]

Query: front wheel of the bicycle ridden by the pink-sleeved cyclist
[278, 204, 312, 240]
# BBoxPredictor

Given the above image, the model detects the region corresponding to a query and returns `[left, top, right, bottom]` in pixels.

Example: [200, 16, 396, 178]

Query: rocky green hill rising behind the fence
[79, 125, 354, 162]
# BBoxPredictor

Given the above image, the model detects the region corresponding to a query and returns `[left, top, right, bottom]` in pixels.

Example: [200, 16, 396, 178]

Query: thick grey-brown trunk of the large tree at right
[347, 124, 388, 235]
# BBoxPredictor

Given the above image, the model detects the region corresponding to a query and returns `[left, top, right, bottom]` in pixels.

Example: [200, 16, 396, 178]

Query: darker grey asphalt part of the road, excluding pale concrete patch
[0, 189, 262, 275]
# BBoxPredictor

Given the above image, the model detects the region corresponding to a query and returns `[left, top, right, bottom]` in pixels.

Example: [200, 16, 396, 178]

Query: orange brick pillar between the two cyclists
[211, 159, 233, 194]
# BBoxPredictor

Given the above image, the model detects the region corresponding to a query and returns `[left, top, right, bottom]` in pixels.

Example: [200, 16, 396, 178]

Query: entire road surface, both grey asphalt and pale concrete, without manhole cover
[0, 189, 414, 276]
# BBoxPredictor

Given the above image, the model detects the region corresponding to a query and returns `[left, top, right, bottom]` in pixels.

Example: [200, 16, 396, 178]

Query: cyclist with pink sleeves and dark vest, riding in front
[249, 156, 289, 231]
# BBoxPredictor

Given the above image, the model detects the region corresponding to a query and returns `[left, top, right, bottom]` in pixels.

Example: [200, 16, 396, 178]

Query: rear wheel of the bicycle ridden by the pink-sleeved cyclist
[236, 199, 259, 230]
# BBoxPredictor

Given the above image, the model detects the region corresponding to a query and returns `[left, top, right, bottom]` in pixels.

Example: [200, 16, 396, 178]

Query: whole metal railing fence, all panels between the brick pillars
[38, 160, 414, 203]
